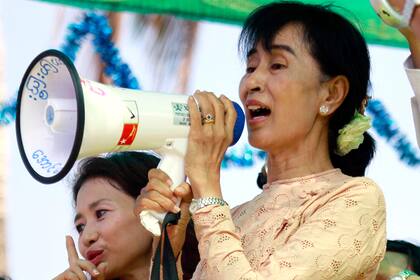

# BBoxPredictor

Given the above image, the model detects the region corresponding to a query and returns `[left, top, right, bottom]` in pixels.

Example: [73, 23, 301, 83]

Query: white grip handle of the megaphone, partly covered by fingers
[140, 153, 185, 236]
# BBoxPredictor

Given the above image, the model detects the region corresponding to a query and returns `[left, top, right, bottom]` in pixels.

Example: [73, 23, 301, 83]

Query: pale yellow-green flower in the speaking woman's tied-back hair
[335, 111, 371, 156]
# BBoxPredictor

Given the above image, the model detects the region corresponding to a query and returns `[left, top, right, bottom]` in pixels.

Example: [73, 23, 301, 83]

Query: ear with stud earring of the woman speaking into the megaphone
[319, 75, 350, 115]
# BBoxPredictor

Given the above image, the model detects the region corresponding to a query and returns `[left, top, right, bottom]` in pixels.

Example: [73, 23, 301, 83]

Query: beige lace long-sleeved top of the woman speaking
[193, 169, 386, 280]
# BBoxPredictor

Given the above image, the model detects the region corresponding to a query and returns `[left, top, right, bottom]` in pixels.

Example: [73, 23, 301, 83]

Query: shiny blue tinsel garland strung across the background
[0, 12, 420, 168]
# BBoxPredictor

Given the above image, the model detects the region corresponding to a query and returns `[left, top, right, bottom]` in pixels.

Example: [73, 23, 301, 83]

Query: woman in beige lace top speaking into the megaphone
[136, 1, 386, 280]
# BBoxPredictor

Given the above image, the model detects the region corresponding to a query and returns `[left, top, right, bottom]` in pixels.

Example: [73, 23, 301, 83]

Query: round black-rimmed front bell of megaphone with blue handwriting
[16, 50, 85, 184]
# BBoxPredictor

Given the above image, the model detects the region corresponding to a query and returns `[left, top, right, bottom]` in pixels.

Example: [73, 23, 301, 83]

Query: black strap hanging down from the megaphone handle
[150, 212, 181, 280]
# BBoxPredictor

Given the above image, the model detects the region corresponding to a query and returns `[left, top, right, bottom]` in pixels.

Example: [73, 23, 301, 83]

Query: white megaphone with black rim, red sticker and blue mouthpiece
[16, 50, 245, 235]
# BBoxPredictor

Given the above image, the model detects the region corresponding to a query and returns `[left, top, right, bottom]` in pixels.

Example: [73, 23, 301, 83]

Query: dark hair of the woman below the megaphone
[73, 152, 159, 205]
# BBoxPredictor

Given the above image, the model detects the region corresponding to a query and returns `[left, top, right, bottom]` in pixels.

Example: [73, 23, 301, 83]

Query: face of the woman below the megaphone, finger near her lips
[75, 177, 152, 279]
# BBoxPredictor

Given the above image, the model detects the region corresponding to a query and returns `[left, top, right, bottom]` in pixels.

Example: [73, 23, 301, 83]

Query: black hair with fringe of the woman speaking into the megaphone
[238, 1, 375, 176]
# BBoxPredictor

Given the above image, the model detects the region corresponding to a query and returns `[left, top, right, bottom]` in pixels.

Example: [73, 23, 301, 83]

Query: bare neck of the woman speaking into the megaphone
[267, 123, 334, 183]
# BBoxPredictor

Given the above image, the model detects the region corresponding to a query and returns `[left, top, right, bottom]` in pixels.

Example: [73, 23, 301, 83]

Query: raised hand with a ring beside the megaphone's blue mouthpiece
[185, 91, 236, 198]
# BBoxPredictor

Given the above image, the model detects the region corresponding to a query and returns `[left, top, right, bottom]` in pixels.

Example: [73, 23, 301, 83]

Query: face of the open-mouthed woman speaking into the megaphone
[239, 24, 326, 153]
